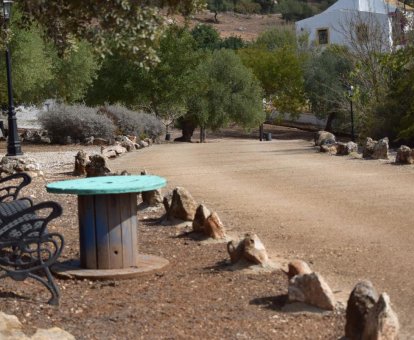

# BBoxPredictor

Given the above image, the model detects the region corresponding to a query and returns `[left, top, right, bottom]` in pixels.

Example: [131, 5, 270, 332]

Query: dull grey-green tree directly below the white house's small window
[304, 47, 352, 118]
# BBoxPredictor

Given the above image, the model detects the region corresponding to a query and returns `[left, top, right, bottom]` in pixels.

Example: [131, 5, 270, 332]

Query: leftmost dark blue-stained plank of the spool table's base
[78, 196, 98, 269]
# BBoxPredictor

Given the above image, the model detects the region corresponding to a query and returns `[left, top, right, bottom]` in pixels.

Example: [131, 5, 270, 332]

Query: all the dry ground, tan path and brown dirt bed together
[0, 127, 414, 339]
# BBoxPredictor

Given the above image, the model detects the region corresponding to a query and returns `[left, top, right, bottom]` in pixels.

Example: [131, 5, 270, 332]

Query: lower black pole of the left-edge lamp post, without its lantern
[6, 46, 23, 156]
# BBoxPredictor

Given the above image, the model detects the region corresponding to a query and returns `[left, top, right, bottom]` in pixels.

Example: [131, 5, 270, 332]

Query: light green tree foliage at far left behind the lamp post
[0, 12, 98, 104]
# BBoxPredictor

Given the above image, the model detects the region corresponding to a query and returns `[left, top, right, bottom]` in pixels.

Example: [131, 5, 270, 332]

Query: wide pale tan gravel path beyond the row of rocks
[111, 128, 414, 339]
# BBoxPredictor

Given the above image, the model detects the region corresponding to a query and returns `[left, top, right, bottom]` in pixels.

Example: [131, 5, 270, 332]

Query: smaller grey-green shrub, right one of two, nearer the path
[99, 105, 164, 138]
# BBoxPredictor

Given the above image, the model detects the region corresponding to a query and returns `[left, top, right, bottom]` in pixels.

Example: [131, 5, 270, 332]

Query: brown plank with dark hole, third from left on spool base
[106, 195, 124, 269]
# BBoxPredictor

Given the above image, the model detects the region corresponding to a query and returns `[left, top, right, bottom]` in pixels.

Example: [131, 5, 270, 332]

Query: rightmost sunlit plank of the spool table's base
[118, 194, 136, 268]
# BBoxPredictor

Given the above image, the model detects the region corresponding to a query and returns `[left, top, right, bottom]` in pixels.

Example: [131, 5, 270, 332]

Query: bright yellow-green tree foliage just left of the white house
[239, 29, 305, 115]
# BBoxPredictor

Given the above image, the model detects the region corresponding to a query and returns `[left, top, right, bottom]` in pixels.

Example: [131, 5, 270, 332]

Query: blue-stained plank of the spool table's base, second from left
[94, 195, 111, 269]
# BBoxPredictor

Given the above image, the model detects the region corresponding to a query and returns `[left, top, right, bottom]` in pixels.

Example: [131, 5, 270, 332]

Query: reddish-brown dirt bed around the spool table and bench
[0, 163, 344, 339]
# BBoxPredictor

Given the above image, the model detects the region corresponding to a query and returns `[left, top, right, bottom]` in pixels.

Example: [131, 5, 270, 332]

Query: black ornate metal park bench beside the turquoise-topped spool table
[0, 174, 64, 305]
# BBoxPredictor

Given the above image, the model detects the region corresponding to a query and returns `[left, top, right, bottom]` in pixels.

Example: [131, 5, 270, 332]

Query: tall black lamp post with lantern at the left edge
[3, 0, 23, 156]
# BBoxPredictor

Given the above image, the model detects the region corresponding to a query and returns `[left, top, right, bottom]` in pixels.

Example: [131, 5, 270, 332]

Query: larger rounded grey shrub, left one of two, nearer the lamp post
[39, 104, 115, 144]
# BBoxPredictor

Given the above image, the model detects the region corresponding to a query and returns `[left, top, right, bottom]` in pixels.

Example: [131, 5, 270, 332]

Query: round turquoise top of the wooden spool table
[46, 175, 167, 195]
